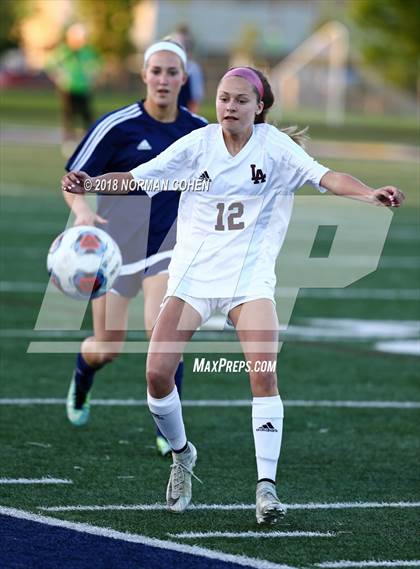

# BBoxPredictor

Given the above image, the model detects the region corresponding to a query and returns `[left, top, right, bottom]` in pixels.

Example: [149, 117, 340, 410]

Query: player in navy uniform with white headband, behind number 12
[65, 40, 206, 455]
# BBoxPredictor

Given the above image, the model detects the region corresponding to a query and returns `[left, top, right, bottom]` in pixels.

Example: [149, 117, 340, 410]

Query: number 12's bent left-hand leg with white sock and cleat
[147, 297, 201, 513]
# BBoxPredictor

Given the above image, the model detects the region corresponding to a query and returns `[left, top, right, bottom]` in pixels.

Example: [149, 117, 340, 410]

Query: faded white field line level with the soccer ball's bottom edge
[0, 281, 420, 301]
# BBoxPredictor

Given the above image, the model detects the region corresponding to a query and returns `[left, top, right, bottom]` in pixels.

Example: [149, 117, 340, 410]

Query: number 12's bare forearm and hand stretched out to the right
[319, 170, 405, 207]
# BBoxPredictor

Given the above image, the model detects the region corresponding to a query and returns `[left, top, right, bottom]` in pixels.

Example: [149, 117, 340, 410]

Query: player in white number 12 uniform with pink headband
[62, 64, 404, 524]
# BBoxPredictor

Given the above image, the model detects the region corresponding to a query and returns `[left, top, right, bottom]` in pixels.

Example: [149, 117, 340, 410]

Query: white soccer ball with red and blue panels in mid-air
[47, 225, 122, 300]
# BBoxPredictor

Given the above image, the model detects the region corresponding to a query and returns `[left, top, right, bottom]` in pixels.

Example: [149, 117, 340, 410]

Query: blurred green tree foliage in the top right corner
[349, 0, 420, 93]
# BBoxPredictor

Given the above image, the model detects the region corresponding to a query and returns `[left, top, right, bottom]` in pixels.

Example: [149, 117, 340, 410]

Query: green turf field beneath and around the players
[0, 104, 420, 569]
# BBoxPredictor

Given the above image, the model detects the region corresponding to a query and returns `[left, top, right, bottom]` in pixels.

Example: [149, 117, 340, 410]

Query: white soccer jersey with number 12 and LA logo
[131, 124, 328, 298]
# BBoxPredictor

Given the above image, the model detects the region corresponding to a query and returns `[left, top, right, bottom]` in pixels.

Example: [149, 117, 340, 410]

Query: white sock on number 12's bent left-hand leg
[147, 387, 187, 450]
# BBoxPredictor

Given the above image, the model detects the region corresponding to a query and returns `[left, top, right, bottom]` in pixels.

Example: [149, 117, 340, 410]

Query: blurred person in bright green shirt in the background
[46, 23, 101, 150]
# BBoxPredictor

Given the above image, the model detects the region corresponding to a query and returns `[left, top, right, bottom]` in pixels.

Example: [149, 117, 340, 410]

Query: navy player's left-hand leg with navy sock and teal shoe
[66, 293, 130, 427]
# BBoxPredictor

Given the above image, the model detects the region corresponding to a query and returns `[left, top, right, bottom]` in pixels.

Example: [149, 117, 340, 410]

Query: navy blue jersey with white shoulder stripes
[66, 102, 207, 265]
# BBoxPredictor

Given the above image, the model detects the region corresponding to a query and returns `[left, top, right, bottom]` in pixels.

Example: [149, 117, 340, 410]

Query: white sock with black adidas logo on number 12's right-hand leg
[252, 395, 284, 482]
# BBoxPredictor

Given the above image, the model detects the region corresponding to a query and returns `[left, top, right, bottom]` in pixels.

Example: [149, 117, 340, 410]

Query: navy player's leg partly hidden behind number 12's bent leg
[143, 273, 184, 456]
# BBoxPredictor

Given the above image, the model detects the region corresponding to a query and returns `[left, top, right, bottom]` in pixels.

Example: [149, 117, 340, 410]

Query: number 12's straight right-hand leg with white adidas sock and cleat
[229, 299, 286, 524]
